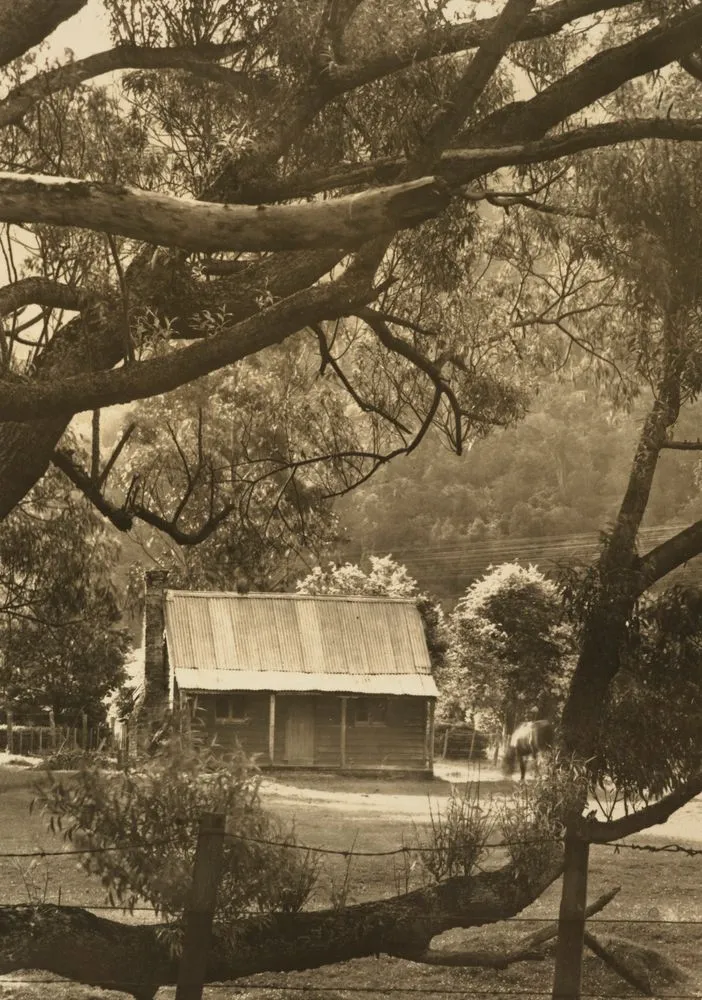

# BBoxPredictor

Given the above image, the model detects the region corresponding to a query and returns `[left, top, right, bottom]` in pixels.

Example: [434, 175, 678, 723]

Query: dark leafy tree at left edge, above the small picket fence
[0, 460, 130, 725]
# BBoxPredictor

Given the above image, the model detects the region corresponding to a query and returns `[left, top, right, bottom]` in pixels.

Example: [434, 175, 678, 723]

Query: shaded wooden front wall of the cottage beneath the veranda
[192, 691, 431, 771]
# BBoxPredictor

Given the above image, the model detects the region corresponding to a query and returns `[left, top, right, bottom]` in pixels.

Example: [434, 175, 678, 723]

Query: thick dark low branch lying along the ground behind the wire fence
[0, 850, 563, 1000]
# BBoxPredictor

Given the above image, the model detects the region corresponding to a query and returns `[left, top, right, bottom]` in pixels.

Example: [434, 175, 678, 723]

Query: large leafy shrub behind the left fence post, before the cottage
[33, 734, 317, 922]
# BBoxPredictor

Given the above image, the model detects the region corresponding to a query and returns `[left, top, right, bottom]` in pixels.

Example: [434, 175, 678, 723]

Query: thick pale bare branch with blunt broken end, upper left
[0, 171, 449, 252]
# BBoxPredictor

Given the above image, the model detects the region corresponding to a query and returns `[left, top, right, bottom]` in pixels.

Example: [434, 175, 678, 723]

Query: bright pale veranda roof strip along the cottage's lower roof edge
[175, 667, 439, 698]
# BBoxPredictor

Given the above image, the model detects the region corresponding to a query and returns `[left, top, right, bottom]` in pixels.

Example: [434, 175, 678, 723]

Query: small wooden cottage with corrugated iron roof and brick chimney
[145, 572, 437, 774]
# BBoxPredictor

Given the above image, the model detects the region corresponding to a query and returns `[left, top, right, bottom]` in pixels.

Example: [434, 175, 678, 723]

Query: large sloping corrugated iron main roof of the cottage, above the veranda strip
[166, 590, 435, 696]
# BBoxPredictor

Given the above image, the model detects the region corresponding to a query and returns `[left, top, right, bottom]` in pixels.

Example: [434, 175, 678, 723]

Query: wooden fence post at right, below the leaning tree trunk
[552, 832, 590, 1000]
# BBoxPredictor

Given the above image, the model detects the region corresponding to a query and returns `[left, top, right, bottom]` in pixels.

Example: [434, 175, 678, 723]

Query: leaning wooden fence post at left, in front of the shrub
[175, 813, 225, 1000]
